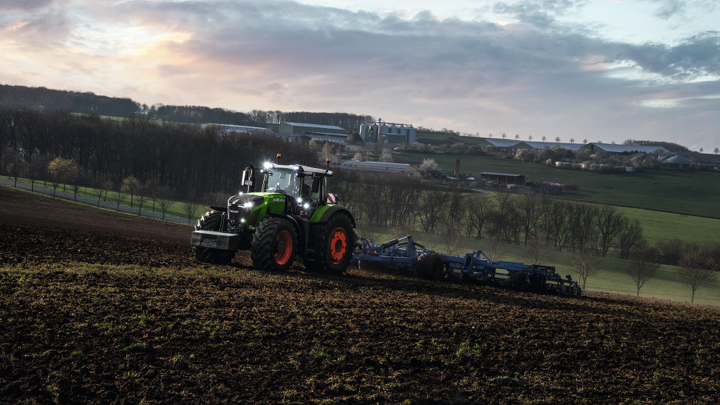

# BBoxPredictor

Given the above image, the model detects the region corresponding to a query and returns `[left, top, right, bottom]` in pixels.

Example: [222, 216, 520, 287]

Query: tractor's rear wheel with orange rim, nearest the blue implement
[311, 213, 355, 274]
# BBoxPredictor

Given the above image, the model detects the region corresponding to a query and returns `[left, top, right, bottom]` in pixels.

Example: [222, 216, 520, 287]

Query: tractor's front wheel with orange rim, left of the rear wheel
[250, 217, 298, 271]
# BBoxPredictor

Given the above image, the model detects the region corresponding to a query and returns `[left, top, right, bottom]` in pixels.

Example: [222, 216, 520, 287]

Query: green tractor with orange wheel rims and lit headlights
[192, 154, 356, 273]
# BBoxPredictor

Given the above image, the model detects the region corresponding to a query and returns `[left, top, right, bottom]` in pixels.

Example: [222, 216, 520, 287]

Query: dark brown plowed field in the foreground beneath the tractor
[0, 187, 720, 404]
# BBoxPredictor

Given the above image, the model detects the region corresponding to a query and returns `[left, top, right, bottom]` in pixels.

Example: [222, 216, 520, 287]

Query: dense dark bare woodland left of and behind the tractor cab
[0, 108, 317, 199]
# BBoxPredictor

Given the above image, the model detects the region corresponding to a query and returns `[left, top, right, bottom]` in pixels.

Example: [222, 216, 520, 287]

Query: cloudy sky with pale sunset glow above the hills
[0, 0, 720, 152]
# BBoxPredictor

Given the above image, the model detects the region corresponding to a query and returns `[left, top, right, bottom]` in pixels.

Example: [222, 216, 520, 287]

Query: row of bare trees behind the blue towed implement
[333, 171, 644, 258]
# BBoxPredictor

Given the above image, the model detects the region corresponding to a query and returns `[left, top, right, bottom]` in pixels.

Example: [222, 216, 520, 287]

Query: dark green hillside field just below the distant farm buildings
[393, 152, 720, 218]
